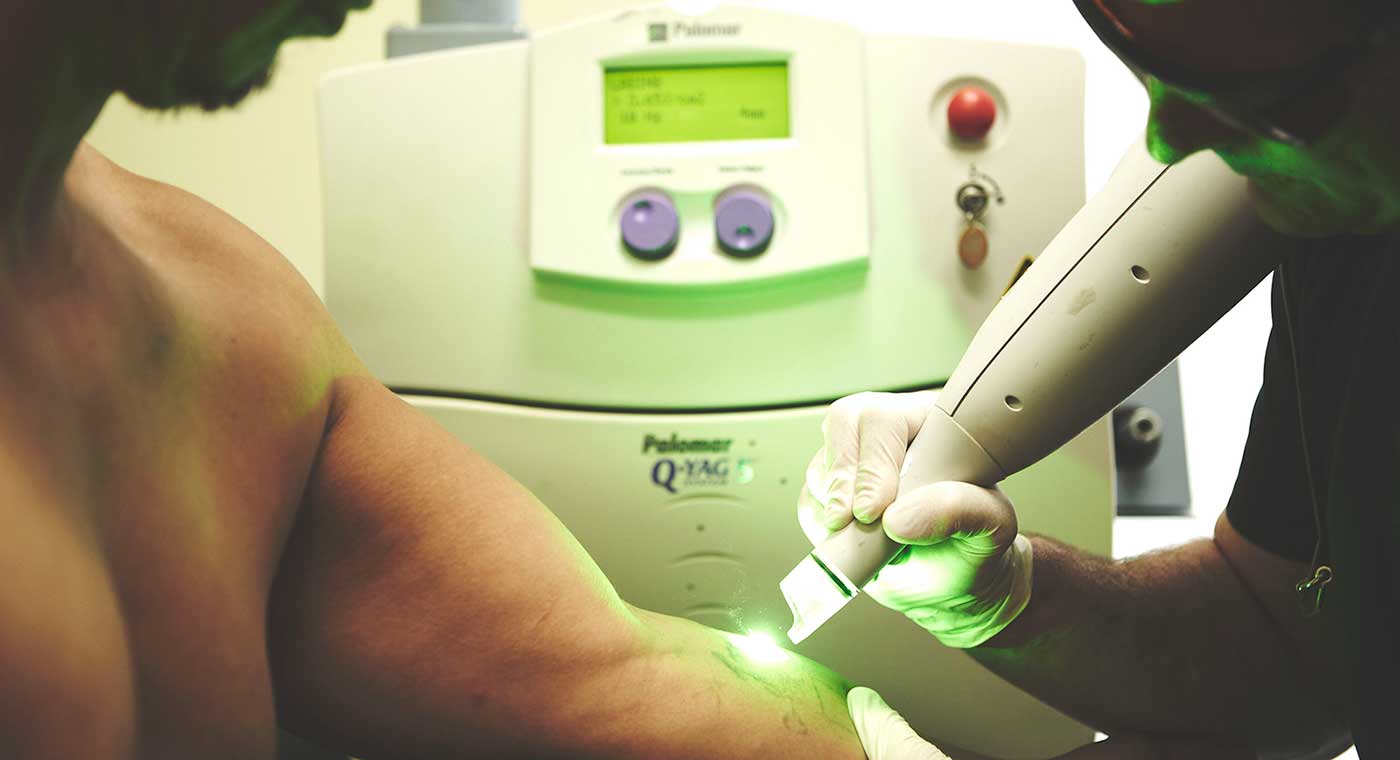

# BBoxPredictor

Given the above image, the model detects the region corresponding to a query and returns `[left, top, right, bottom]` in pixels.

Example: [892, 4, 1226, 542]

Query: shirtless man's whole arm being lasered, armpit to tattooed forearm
[269, 375, 860, 757]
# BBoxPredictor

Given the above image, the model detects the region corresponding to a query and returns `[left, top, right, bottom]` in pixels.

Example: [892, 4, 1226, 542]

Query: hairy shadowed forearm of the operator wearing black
[970, 537, 1324, 740]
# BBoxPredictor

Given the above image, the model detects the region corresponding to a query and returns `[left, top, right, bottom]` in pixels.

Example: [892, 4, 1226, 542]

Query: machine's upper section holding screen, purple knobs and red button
[319, 4, 1084, 410]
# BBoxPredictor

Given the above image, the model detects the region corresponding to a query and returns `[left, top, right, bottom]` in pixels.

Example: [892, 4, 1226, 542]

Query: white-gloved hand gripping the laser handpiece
[798, 390, 1032, 648]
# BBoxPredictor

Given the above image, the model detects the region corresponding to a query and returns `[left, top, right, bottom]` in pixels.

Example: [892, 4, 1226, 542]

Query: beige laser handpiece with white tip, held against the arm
[778, 140, 1292, 642]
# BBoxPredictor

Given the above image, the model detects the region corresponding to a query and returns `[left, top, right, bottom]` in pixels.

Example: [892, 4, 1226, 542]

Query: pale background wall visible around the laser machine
[90, 0, 1268, 533]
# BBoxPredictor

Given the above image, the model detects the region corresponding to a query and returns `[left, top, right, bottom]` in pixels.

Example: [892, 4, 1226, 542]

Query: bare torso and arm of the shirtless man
[0, 1, 864, 760]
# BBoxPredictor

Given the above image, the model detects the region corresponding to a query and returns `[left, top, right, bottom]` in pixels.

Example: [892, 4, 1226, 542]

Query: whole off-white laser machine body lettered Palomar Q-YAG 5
[319, 6, 1113, 759]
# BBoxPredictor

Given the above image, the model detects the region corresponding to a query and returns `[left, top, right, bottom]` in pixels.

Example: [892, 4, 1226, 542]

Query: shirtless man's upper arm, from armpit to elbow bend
[272, 377, 652, 752]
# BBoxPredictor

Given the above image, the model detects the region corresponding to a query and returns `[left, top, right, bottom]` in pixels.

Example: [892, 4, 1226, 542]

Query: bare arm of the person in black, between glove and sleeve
[969, 515, 1347, 759]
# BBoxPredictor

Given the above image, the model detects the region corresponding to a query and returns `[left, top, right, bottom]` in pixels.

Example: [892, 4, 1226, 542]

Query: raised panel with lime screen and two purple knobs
[529, 7, 871, 287]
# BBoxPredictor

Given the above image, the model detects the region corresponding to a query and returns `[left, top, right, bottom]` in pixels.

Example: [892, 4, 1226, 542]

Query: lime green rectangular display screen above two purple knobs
[603, 63, 790, 144]
